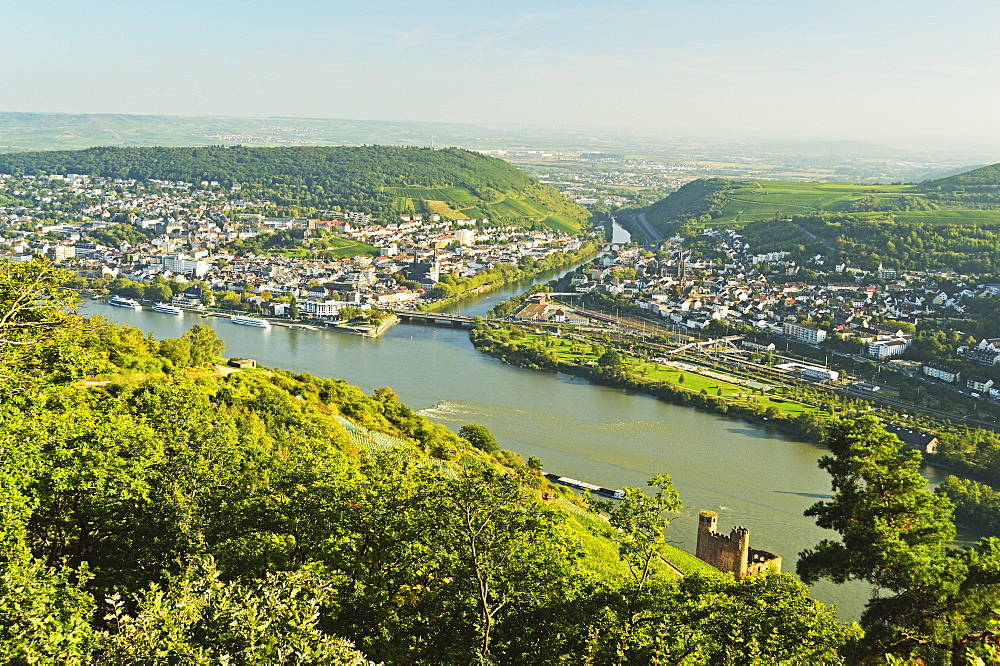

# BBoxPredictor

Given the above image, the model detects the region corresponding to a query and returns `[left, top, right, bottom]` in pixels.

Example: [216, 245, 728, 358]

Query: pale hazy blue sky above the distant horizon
[7, 0, 1000, 138]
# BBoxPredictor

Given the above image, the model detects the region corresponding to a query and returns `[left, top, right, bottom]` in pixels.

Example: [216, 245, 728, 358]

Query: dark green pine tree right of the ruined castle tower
[797, 416, 1000, 664]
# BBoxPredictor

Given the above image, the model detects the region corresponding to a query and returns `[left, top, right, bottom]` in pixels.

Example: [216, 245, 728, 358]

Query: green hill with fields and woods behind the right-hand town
[640, 164, 1000, 275]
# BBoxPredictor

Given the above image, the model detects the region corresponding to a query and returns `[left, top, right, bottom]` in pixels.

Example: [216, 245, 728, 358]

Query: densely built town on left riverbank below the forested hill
[0, 174, 585, 323]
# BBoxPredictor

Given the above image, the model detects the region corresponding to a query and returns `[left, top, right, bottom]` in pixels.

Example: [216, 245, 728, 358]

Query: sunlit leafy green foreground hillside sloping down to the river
[0, 260, 859, 665]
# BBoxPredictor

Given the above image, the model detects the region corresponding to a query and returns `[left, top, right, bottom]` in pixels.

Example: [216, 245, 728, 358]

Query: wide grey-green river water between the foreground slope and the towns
[74, 224, 937, 619]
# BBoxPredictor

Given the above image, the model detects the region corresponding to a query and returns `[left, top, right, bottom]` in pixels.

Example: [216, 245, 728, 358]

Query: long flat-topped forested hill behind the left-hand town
[0, 146, 589, 231]
